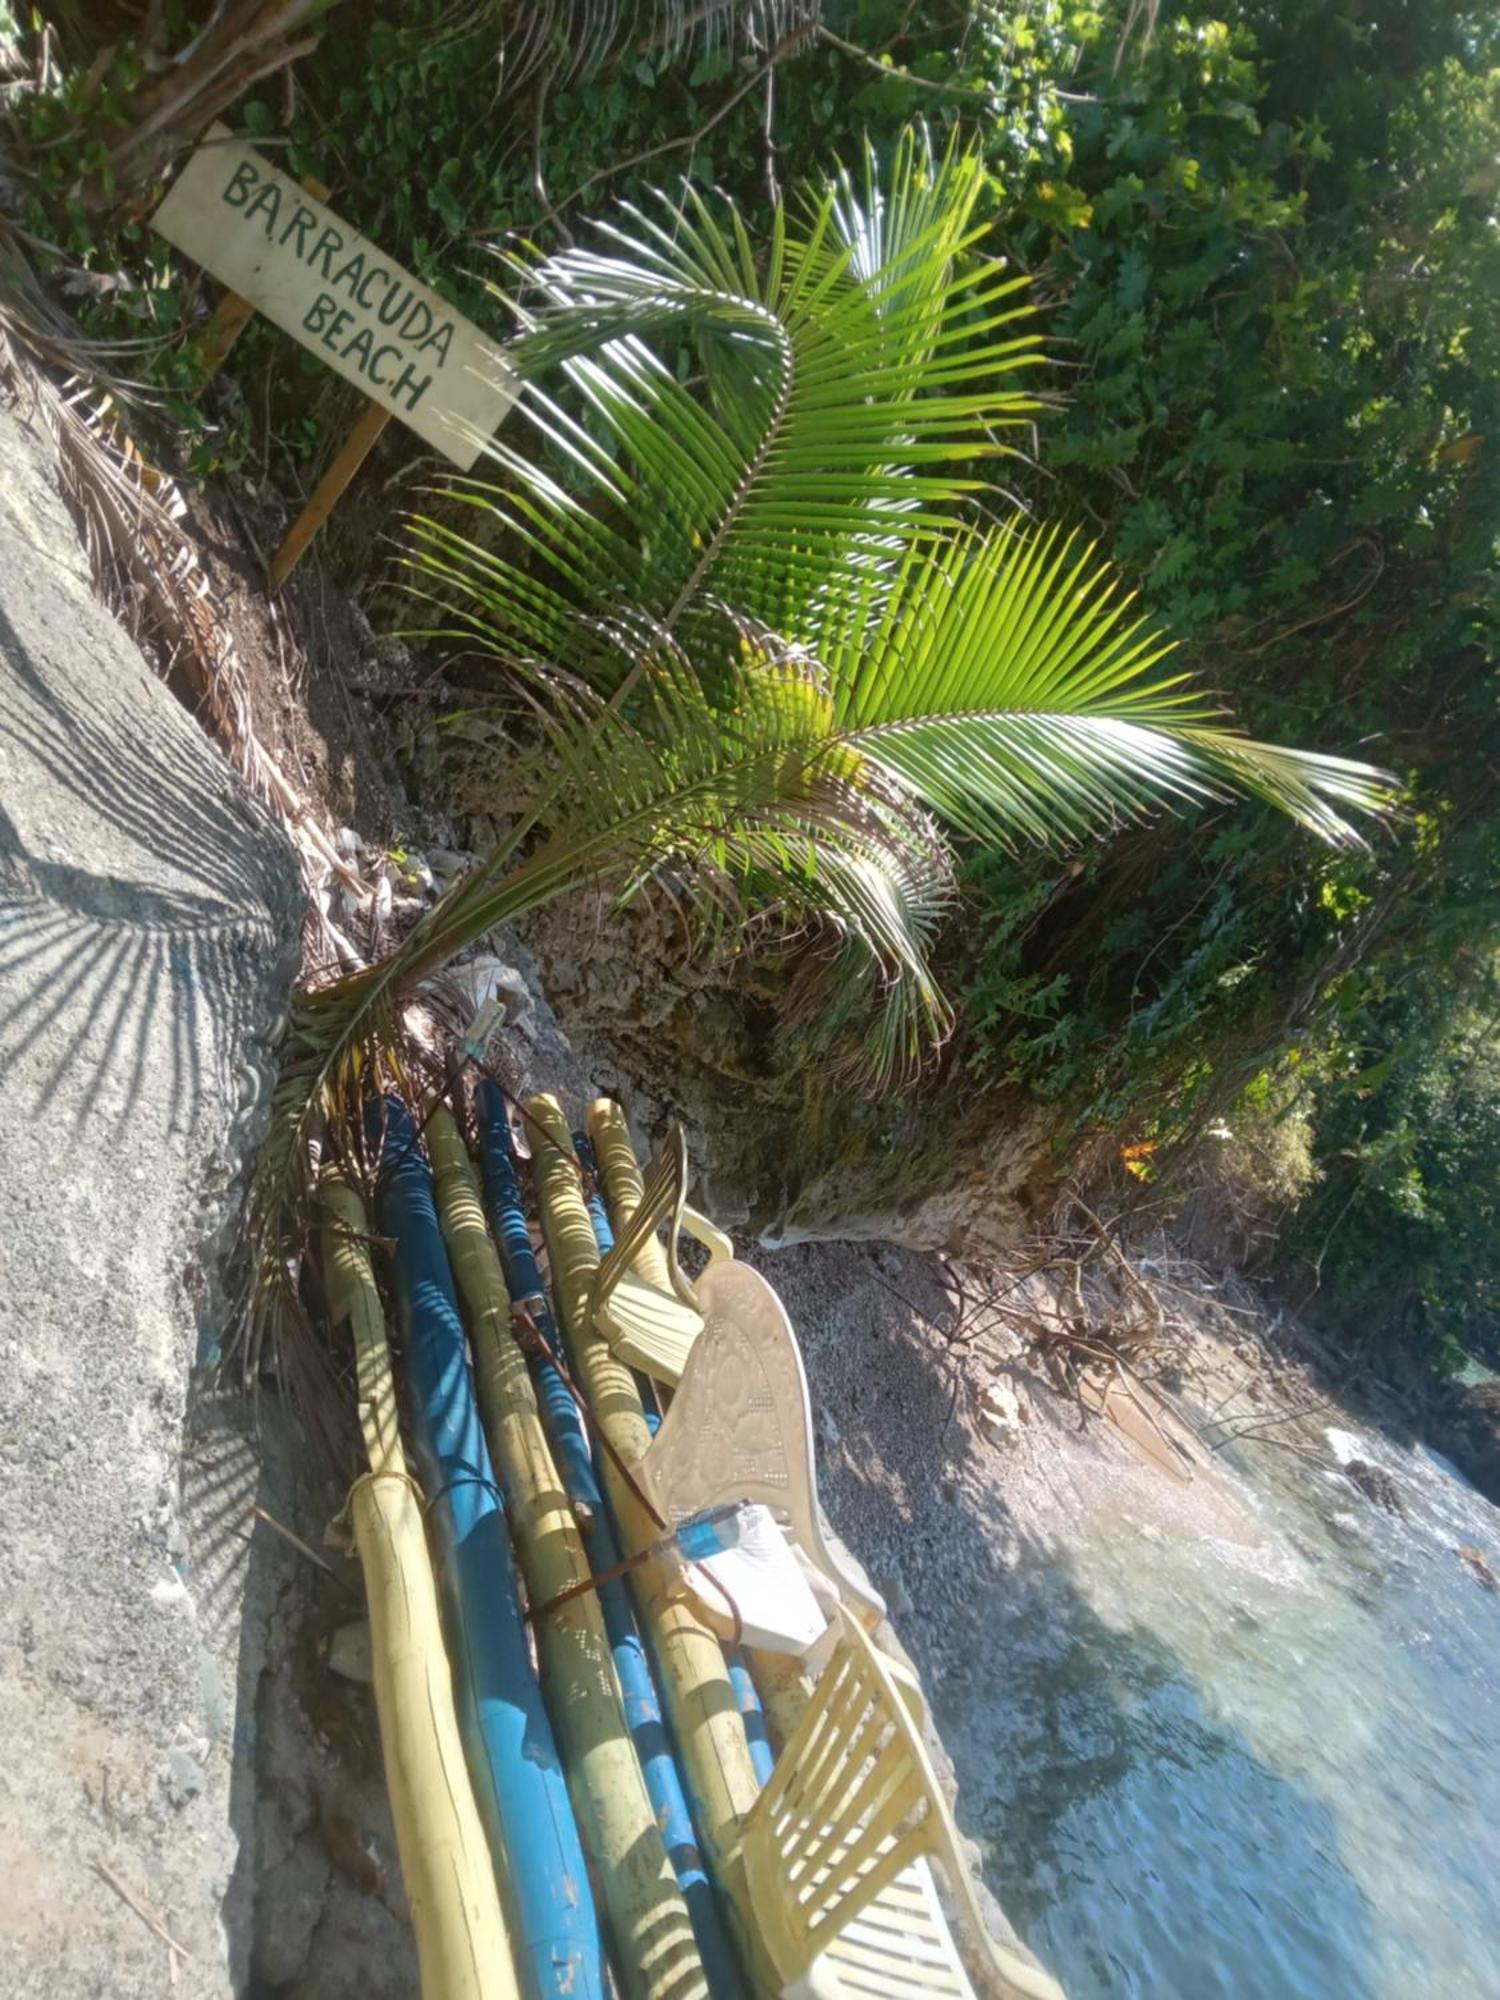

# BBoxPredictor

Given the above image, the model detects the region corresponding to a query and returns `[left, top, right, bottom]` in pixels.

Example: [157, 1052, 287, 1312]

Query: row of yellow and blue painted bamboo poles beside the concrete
[320, 1080, 808, 2000]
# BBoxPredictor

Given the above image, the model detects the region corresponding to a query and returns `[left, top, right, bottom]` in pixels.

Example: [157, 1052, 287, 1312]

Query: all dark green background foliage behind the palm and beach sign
[14, 0, 1500, 1376]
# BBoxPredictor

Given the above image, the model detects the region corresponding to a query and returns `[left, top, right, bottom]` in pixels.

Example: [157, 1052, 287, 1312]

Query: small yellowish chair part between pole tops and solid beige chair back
[590, 1126, 734, 1384]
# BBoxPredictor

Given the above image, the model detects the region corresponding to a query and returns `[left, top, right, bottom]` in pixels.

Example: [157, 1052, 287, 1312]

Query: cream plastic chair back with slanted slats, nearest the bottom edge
[744, 1610, 1062, 2000]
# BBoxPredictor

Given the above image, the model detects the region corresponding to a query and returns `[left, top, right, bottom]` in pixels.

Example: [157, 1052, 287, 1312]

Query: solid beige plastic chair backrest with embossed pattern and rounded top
[638, 1260, 886, 1622]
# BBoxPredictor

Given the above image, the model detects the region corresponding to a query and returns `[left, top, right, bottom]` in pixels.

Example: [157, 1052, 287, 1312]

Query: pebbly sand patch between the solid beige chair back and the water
[752, 1244, 1280, 1592]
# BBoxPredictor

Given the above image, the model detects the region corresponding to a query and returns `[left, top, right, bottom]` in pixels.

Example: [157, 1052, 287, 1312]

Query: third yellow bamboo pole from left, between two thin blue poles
[526, 1096, 780, 1994]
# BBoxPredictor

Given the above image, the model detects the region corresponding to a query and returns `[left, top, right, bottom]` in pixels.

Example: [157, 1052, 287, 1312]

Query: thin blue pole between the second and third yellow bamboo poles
[480, 1078, 744, 2000]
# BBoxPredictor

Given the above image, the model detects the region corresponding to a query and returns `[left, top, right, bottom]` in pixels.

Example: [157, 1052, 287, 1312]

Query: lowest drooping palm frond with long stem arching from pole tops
[250, 634, 952, 1358]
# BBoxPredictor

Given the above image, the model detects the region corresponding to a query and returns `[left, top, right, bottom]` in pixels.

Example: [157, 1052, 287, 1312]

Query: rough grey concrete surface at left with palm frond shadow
[0, 394, 298, 2000]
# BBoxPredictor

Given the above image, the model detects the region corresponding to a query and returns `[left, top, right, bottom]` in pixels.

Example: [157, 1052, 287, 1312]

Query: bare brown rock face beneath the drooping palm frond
[526, 894, 1052, 1256]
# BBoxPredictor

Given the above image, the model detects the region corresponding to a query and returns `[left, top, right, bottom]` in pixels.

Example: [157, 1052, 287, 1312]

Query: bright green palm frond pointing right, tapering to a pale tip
[826, 528, 1390, 846]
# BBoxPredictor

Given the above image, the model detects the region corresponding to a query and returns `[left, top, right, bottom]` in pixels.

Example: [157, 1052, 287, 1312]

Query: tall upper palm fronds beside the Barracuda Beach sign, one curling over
[412, 134, 1040, 680]
